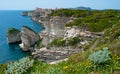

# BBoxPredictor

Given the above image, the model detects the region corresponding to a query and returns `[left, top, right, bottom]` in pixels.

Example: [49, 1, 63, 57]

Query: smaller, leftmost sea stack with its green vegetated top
[7, 28, 21, 43]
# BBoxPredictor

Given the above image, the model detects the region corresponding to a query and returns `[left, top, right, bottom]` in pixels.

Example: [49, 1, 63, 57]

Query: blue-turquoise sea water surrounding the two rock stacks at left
[0, 10, 43, 63]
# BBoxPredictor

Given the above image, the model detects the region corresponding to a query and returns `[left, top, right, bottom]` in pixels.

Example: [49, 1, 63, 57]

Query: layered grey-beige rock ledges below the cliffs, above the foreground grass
[32, 47, 81, 63]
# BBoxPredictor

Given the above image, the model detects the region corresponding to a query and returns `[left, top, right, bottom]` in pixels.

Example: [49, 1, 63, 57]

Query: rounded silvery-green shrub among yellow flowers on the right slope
[88, 47, 111, 64]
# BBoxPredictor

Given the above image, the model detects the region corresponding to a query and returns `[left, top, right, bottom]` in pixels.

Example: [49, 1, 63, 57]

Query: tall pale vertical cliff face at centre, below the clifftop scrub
[38, 16, 70, 46]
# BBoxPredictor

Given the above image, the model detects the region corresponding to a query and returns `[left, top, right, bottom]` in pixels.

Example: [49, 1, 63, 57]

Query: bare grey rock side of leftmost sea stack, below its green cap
[7, 32, 21, 43]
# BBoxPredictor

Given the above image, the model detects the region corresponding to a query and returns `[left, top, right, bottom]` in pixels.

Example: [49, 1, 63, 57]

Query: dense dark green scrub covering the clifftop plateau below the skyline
[51, 9, 120, 32]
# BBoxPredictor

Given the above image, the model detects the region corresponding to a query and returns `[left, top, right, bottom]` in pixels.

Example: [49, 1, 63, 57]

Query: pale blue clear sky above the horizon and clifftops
[0, 0, 120, 10]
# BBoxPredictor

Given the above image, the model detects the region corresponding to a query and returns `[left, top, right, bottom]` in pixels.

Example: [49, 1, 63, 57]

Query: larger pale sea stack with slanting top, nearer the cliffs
[20, 26, 40, 51]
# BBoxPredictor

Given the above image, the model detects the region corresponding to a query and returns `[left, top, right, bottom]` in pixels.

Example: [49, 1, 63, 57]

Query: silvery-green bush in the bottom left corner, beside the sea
[5, 57, 34, 74]
